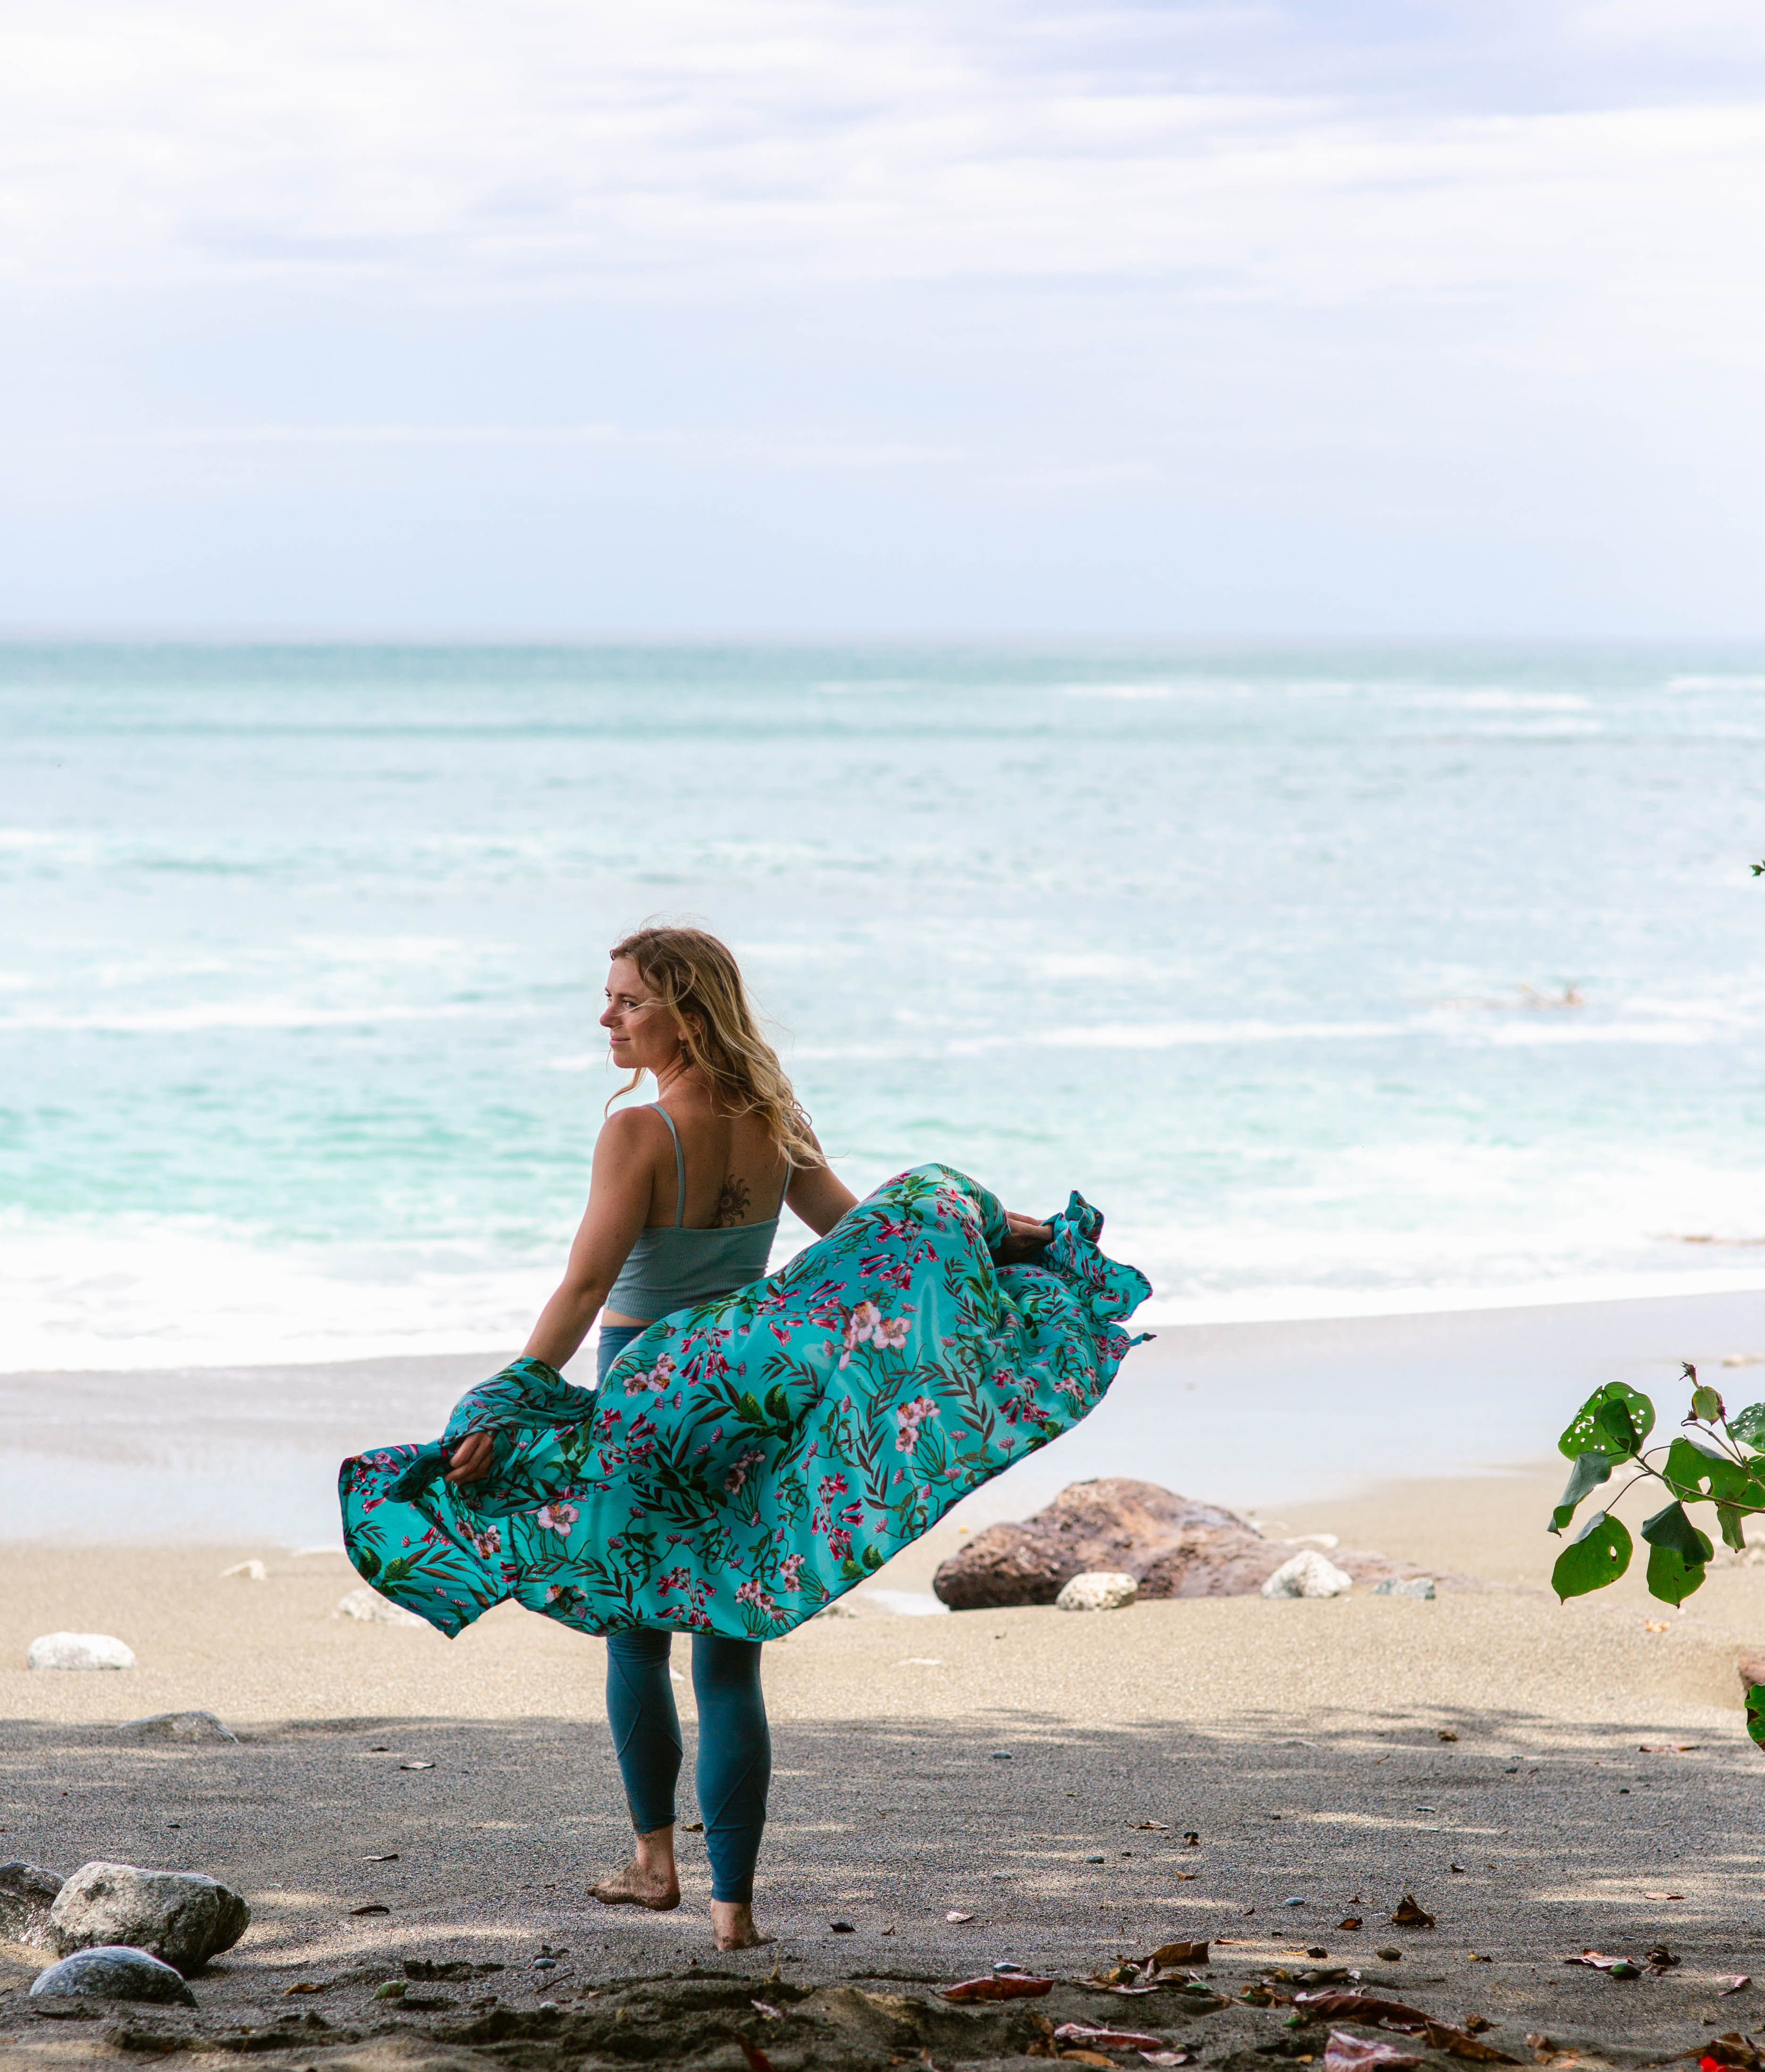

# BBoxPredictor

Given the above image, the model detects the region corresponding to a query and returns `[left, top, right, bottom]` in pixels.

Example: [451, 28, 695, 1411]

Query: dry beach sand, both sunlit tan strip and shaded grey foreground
[0, 1469, 1765, 2072]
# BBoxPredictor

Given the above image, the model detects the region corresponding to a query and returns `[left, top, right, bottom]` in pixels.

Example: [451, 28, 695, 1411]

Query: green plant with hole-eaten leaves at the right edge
[1549, 1362, 1765, 1749]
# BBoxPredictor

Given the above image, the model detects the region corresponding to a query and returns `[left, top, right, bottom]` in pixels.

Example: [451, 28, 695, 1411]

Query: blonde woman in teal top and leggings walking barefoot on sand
[445, 928, 1050, 1950]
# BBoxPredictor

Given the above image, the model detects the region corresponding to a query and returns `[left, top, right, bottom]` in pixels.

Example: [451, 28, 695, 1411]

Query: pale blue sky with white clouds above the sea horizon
[0, 0, 1765, 638]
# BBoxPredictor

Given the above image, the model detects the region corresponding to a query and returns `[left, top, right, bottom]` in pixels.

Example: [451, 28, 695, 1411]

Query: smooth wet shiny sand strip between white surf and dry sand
[0, 1293, 1765, 1548]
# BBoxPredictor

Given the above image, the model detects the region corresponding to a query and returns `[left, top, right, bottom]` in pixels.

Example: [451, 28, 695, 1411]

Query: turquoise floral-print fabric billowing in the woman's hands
[338, 1164, 1152, 1641]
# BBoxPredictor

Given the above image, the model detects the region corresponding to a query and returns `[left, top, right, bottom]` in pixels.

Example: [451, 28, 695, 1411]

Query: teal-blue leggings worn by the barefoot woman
[601, 1324, 773, 1902]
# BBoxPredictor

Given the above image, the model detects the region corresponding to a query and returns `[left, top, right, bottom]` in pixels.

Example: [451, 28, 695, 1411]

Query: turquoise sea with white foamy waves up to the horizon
[0, 644, 1765, 1368]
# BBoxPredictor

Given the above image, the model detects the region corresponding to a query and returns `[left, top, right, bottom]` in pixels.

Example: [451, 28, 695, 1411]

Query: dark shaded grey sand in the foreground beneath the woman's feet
[0, 1693, 1765, 2072]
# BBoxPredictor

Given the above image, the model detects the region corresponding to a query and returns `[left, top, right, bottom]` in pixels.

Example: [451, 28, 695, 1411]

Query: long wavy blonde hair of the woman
[607, 926, 824, 1167]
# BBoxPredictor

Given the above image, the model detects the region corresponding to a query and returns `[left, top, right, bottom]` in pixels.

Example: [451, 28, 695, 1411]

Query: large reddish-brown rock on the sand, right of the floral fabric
[932, 1475, 1458, 1612]
